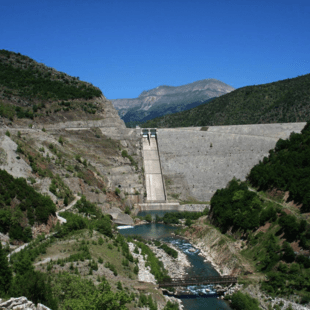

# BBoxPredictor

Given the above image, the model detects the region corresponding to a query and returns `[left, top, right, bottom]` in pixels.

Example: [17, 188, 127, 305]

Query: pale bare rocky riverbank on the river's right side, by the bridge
[178, 219, 310, 310]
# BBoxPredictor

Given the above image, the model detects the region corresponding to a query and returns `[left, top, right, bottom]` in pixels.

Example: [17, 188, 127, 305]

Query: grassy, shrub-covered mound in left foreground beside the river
[0, 197, 173, 310]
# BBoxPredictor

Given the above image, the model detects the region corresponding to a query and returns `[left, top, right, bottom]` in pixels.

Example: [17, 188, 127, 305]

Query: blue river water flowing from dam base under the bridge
[120, 212, 231, 310]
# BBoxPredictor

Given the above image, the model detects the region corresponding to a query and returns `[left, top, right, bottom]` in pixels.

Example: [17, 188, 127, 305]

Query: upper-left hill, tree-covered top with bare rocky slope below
[0, 50, 118, 125]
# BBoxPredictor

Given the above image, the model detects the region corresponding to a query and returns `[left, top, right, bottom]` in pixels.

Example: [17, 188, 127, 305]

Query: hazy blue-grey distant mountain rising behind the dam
[111, 79, 234, 124]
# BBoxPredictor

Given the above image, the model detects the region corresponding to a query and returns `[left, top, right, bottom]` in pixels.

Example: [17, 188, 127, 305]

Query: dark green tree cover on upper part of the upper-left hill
[0, 50, 102, 101]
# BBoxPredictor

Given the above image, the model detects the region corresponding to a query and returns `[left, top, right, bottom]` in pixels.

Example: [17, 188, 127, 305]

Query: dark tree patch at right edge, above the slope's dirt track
[248, 122, 310, 212]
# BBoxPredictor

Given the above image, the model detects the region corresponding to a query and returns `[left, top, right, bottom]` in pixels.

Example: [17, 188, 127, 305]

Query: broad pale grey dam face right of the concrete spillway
[157, 123, 306, 202]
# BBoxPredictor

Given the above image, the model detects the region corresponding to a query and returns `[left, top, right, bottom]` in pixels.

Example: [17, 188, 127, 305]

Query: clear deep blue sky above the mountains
[0, 0, 310, 99]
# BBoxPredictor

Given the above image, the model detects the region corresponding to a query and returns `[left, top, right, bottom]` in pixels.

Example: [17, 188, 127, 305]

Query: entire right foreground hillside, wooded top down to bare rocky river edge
[182, 122, 310, 309]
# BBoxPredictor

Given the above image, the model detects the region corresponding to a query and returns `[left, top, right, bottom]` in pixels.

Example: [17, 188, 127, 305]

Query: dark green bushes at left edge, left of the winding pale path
[0, 170, 56, 242]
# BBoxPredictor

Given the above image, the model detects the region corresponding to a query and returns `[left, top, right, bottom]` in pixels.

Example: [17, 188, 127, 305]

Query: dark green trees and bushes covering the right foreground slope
[210, 123, 310, 302]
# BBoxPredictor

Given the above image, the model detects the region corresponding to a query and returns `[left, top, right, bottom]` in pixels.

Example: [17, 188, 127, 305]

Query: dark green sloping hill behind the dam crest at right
[141, 74, 310, 128]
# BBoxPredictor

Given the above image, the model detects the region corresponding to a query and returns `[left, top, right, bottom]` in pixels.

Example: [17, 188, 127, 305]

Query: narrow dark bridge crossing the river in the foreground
[158, 276, 238, 287]
